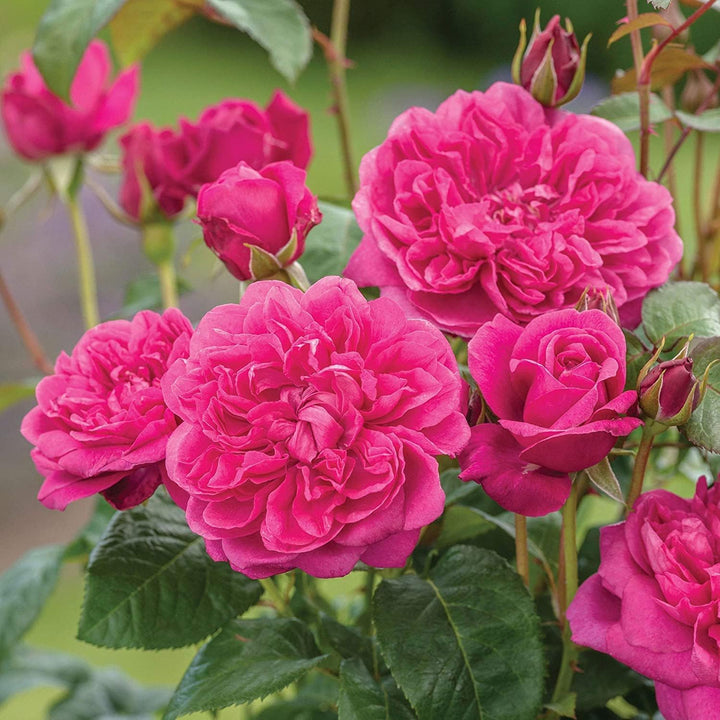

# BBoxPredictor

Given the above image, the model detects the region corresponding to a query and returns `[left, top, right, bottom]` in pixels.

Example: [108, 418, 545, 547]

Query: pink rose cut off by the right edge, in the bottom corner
[567, 478, 720, 720]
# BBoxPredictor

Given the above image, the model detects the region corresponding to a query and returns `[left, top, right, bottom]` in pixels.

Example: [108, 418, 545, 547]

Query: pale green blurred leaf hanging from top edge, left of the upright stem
[206, 0, 312, 82]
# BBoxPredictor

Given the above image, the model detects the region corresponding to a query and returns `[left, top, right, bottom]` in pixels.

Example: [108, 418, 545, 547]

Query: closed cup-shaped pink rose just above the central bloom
[197, 161, 322, 280]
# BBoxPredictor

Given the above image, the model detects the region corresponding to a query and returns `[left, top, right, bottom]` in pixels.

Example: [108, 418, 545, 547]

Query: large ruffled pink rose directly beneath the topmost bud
[345, 83, 682, 337]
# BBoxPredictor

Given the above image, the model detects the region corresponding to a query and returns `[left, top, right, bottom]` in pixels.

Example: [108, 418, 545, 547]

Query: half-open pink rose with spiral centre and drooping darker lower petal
[460, 310, 641, 516]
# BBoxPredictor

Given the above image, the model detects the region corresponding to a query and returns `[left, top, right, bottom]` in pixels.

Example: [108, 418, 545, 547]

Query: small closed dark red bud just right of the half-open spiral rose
[638, 357, 702, 426]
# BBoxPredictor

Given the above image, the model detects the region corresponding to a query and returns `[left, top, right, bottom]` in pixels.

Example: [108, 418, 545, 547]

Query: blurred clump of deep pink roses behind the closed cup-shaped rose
[120, 90, 312, 220]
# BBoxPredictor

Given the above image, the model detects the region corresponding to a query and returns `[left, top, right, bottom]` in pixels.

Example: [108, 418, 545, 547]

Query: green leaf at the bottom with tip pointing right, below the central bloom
[164, 618, 327, 720]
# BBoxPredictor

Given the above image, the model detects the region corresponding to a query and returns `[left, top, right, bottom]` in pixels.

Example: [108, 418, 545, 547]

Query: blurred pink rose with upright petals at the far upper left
[0, 40, 139, 160]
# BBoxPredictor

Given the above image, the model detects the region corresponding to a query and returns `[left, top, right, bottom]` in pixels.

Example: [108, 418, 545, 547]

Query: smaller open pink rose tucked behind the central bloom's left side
[21, 309, 192, 510]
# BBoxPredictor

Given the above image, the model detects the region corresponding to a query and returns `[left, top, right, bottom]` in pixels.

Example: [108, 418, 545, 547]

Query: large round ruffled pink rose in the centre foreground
[162, 277, 469, 578]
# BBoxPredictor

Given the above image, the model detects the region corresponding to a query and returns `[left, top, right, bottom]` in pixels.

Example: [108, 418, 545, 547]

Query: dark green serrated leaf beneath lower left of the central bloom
[78, 492, 262, 649]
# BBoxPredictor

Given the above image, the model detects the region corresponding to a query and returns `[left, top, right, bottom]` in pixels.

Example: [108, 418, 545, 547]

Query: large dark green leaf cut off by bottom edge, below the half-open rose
[373, 546, 544, 720]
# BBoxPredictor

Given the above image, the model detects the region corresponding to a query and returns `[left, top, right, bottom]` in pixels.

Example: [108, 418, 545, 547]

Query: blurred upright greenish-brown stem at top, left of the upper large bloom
[315, 0, 357, 199]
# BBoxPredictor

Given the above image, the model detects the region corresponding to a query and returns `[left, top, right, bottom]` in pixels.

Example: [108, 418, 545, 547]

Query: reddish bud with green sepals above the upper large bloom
[512, 9, 590, 107]
